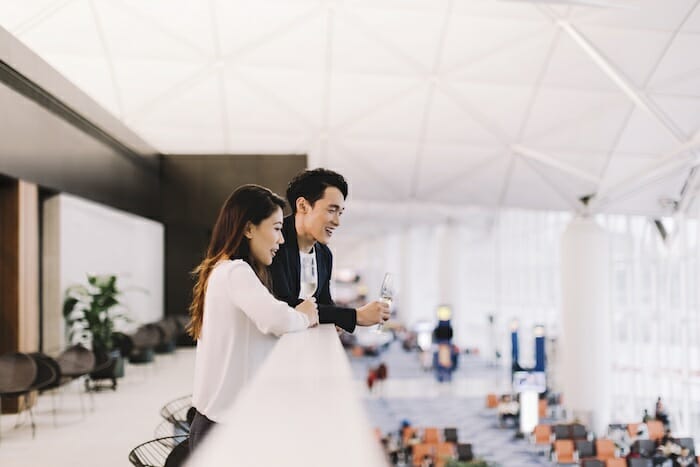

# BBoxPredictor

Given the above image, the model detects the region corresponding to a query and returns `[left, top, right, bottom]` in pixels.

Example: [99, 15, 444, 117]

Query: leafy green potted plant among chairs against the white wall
[63, 275, 128, 389]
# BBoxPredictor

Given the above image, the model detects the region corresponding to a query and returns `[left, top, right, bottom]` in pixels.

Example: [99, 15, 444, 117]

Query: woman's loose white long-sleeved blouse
[192, 259, 309, 422]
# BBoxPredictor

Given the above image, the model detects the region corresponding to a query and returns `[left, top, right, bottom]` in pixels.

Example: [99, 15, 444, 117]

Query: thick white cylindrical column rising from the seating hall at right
[559, 217, 611, 435]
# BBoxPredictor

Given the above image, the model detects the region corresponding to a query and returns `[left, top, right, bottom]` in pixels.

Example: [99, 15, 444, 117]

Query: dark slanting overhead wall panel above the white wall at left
[0, 80, 160, 219]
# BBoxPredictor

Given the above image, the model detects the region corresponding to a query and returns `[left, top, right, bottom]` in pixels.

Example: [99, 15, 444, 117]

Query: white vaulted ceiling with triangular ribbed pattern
[0, 0, 700, 215]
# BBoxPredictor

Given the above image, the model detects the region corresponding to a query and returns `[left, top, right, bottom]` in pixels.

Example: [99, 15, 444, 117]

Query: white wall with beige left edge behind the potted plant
[44, 194, 164, 352]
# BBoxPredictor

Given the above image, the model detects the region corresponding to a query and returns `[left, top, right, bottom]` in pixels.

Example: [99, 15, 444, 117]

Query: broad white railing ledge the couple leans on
[188, 325, 388, 467]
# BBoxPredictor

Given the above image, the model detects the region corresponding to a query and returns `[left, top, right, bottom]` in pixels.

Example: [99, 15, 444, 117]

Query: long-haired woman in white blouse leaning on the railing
[188, 185, 318, 450]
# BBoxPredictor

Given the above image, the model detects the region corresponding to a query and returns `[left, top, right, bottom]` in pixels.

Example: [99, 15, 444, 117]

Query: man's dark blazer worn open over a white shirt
[270, 215, 357, 332]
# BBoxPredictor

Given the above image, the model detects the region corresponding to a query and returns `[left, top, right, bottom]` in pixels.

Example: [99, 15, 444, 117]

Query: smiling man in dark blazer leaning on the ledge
[271, 169, 390, 332]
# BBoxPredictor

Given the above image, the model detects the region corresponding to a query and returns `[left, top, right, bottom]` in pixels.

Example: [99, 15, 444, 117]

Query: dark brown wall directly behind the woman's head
[161, 155, 306, 314]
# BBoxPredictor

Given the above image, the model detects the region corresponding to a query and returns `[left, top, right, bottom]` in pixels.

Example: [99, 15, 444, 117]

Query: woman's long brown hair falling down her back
[187, 185, 284, 339]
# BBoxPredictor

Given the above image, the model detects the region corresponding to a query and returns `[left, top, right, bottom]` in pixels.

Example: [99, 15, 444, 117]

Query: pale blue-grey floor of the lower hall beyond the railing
[351, 344, 551, 467]
